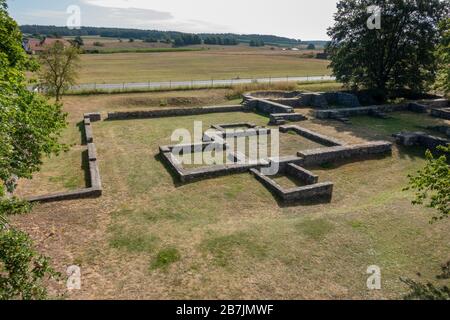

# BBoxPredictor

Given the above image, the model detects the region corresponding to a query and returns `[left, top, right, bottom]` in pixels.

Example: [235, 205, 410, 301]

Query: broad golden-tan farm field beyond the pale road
[79, 46, 330, 83]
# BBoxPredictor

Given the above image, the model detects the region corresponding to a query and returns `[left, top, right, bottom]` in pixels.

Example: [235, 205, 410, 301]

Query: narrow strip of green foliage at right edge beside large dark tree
[435, 18, 450, 95]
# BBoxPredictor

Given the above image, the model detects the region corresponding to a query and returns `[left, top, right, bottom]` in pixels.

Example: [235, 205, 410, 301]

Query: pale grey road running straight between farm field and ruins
[71, 76, 335, 91]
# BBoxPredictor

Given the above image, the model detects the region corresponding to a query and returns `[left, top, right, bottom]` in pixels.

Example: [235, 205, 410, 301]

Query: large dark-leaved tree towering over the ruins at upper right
[328, 0, 449, 96]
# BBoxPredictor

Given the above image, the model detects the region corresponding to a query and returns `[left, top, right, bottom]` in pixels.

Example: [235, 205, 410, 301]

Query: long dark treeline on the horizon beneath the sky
[20, 25, 302, 46]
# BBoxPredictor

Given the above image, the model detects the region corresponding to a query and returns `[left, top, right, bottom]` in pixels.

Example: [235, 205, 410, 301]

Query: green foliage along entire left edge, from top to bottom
[0, 0, 66, 299]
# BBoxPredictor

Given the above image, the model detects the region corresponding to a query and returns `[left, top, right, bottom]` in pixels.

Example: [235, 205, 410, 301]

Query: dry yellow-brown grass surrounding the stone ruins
[12, 90, 450, 299]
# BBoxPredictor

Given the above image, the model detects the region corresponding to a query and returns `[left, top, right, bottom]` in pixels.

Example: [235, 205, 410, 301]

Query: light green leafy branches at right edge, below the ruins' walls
[405, 146, 450, 222]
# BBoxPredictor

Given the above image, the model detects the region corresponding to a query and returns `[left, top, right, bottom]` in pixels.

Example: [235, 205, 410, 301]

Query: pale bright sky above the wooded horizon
[7, 0, 337, 40]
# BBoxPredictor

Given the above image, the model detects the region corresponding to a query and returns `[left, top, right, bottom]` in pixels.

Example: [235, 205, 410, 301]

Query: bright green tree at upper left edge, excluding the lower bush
[0, 0, 66, 198]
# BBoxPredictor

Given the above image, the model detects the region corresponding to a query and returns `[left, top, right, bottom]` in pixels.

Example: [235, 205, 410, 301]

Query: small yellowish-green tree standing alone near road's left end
[39, 41, 80, 102]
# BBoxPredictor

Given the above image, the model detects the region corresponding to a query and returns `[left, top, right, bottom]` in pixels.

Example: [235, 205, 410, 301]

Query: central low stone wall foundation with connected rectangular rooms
[160, 123, 392, 202]
